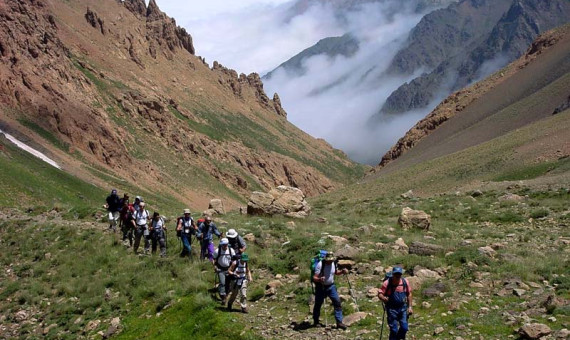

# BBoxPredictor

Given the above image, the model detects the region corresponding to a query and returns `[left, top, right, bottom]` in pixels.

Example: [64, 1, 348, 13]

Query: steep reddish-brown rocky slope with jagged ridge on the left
[0, 0, 360, 210]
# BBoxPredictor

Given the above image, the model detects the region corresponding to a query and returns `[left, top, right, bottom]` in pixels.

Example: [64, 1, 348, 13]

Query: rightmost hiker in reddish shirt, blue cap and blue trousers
[378, 266, 414, 340]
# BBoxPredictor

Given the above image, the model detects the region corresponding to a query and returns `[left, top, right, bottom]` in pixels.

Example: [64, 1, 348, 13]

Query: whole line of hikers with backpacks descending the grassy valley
[105, 189, 413, 340]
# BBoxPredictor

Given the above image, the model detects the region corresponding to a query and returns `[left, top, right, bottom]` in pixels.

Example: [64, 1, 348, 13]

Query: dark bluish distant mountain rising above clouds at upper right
[381, 0, 570, 114]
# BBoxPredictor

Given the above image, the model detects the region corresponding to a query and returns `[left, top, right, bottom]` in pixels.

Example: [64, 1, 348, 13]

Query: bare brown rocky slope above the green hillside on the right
[372, 25, 570, 167]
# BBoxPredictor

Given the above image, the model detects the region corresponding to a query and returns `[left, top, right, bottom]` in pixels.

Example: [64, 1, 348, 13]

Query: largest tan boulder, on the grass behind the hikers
[247, 185, 311, 218]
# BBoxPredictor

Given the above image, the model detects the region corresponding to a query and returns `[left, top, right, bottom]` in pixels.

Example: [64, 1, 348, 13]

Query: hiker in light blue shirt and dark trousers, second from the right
[313, 252, 348, 330]
